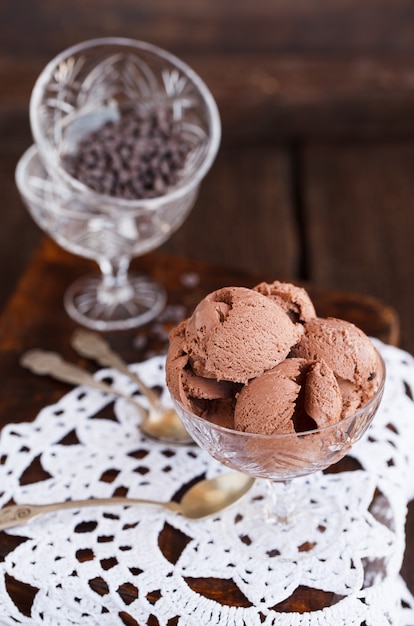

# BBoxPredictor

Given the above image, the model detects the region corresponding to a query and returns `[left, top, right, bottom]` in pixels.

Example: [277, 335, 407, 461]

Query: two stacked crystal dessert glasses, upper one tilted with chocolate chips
[16, 38, 221, 330]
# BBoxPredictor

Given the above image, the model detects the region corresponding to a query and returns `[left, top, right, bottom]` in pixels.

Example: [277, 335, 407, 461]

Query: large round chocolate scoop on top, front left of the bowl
[183, 287, 303, 383]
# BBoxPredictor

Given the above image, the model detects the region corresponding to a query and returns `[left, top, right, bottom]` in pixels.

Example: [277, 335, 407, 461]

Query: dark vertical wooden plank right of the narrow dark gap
[303, 143, 414, 352]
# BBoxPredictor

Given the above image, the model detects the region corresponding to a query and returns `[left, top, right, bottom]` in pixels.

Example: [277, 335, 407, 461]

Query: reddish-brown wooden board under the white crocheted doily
[0, 240, 414, 613]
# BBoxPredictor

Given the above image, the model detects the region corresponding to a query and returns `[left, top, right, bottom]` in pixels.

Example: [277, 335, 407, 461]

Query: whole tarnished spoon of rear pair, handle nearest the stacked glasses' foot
[71, 329, 194, 444]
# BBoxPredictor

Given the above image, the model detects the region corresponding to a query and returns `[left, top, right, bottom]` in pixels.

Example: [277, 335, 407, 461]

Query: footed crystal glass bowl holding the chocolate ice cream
[173, 351, 385, 528]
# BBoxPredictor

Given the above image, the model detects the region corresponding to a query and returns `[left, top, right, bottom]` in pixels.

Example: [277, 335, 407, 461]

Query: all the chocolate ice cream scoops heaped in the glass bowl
[166, 281, 378, 434]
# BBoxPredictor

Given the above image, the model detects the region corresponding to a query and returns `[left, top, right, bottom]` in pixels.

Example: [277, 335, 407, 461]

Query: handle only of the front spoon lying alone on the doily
[0, 497, 181, 530]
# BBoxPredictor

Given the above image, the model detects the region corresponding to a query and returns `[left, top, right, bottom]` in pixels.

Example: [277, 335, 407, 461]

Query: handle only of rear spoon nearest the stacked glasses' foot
[71, 328, 159, 407]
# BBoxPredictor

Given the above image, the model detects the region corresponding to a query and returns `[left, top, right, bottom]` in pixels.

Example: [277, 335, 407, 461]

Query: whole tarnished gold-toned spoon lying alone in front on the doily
[0, 472, 255, 530]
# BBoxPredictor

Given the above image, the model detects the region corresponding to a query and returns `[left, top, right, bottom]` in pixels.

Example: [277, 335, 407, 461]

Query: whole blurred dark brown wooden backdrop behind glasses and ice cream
[0, 0, 414, 352]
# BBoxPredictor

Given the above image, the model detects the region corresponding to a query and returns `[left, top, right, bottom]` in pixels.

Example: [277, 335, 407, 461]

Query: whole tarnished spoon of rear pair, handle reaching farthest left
[20, 349, 193, 444]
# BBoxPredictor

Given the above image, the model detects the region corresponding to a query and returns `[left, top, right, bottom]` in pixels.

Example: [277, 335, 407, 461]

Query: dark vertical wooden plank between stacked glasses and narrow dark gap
[163, 146, 300, 277]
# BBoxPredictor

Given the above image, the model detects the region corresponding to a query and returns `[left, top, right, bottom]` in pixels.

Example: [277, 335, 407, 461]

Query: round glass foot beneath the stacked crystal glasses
[64, 275, 167, 331]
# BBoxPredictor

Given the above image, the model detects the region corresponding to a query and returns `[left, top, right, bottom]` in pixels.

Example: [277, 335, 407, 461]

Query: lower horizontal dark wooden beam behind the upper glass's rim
[5, 54, 414, 143]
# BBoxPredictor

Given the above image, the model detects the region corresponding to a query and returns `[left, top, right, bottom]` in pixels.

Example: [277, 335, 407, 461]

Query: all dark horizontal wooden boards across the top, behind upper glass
[4, 0, 414, 143]
